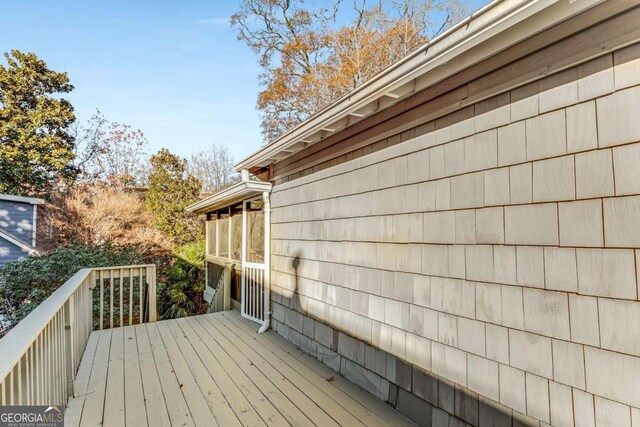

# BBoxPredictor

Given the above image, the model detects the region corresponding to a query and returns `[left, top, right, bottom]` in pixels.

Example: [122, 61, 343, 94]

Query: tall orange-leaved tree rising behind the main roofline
[231, 0, 465, 142]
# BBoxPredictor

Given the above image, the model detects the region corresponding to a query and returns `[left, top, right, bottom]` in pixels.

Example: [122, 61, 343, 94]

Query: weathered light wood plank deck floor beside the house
[65, 311, 411, 427]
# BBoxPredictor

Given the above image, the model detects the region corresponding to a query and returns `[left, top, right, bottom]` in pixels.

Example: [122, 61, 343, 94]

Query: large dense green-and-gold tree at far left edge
[0, 50, 77, 196]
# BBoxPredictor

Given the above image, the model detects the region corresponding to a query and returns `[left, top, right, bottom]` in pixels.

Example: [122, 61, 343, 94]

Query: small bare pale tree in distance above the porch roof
[187, 144, 240, 193]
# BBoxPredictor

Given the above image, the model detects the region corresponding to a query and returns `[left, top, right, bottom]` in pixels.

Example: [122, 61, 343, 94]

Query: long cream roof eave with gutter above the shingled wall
[235, 0, 605, 171]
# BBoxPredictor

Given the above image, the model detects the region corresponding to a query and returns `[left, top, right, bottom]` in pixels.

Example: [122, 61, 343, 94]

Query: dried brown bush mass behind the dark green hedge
[38, 185, 172, 259]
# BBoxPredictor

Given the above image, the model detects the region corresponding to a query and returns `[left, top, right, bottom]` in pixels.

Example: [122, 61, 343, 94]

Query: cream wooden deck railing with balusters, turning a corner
[0, 265, 156, 406]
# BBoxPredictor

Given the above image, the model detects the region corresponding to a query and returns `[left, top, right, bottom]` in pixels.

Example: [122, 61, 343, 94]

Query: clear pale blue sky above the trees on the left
[0, 0, 486, 161]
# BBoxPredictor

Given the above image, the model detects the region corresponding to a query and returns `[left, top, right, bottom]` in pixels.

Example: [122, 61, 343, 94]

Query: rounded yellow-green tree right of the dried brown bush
[146, 148, 204, 244]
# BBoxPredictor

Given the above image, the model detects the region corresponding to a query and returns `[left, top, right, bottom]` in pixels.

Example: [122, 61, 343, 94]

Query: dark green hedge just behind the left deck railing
[0, 244, 143, 323]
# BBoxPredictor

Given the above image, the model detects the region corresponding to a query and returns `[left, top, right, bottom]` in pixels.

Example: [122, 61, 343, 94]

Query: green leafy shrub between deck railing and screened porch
[158, 241, 205, 319]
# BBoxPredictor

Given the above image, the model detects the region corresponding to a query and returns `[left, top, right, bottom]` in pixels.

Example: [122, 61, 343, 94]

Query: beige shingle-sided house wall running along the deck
[271, 38, 640, 426]
